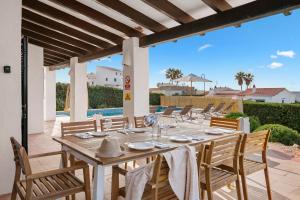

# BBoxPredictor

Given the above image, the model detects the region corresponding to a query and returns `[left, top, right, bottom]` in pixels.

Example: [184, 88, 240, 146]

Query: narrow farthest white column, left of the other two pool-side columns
[44, 67, 56, 121]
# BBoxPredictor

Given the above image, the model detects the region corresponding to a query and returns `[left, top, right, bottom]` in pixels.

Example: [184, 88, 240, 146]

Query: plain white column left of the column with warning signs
[70, 57, 88, 122]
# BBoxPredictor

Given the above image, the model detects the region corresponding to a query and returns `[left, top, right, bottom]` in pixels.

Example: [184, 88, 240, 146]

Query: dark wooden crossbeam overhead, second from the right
[143, 0, 194, 24]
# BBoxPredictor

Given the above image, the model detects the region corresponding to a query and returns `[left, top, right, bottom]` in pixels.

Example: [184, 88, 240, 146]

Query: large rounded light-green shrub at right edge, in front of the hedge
[255, 124, 300, 145]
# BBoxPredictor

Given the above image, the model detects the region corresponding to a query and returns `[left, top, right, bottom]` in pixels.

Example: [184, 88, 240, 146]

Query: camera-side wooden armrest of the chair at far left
[26, 164, 89, 179]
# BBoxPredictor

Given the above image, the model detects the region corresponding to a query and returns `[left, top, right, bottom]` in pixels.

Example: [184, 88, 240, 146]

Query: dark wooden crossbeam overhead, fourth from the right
[50, 0, 144, 37]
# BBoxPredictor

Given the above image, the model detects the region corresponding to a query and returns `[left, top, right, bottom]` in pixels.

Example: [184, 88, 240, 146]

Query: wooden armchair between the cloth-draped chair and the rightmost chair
[198, 134, 242, 200]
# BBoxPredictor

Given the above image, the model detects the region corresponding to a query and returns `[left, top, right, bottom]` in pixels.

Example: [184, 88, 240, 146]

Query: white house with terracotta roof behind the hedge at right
[242, 86, 296, 103]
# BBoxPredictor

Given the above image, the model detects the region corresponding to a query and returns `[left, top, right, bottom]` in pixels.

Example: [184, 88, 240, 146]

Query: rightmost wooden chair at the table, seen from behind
[240, 130, 272, 200]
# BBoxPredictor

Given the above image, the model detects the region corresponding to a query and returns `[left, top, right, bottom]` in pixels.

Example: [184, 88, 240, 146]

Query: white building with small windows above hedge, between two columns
[95, 67, 123, 88]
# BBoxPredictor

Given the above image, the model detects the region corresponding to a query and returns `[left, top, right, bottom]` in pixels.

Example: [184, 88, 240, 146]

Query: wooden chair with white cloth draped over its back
[111, 155, 178, 200]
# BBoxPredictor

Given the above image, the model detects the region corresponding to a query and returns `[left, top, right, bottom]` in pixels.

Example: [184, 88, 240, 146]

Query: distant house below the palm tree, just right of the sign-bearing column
[150, 83, 195, 96]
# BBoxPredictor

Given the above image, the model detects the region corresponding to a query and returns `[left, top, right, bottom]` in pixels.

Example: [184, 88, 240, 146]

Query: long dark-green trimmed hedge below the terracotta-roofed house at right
[244, 101, 300, 132]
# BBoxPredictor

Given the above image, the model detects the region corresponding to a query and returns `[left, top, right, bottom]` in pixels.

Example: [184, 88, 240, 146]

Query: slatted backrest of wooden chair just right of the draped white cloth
[205, 134, 242, 171]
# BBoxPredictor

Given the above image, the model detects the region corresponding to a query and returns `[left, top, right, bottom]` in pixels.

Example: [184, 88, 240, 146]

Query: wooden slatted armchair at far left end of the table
[10, 137, 91, 200]
